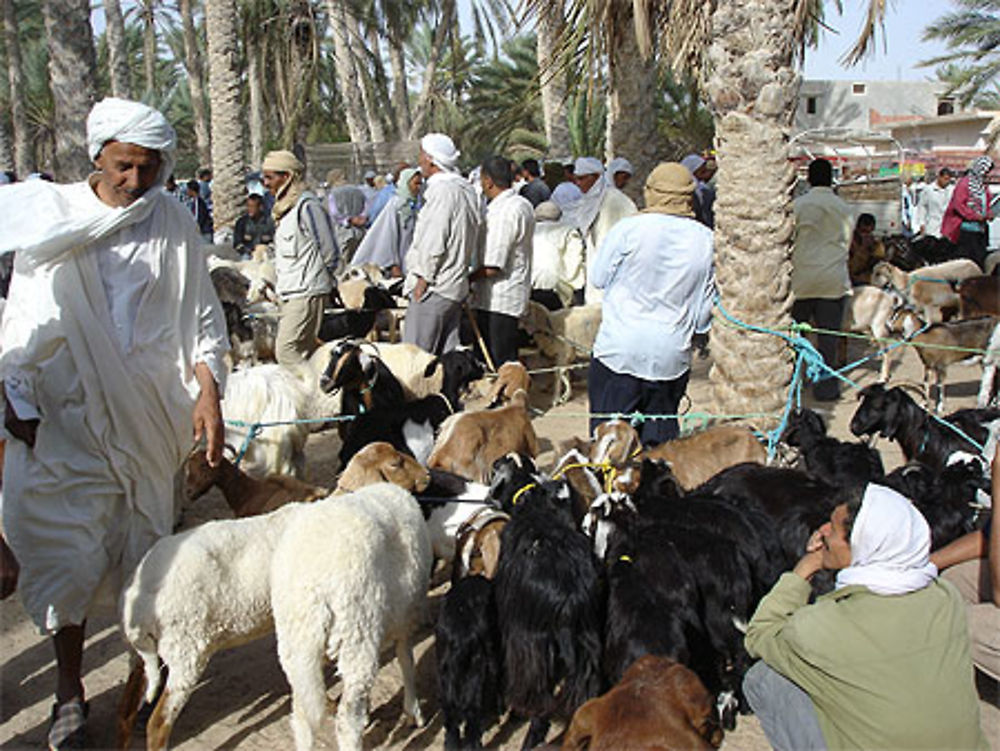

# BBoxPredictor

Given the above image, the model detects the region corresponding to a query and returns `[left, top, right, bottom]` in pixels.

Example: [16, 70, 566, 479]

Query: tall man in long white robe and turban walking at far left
[0, 99, 228, 748]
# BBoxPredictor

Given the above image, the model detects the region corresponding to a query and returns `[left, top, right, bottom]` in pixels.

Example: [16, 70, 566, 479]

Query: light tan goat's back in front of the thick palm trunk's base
[642, 425, 767, 490]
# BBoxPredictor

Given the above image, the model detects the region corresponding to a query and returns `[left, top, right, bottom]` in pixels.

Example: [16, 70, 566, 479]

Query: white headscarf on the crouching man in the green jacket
[837, 483, 937, 595]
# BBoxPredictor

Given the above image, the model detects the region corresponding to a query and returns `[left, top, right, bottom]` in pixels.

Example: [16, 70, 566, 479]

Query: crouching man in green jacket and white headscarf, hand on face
[743, 484, 988, 750]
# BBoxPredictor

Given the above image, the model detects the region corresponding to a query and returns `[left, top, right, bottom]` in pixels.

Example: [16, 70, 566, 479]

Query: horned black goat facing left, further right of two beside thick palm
[851, 383, 1000, 472]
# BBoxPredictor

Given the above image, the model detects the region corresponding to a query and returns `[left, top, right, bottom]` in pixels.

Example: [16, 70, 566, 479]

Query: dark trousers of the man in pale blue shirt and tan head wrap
[587, 357, 690, 446]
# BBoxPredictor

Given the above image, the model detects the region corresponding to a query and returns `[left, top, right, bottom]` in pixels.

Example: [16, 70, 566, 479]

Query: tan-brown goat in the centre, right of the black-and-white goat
[427, 363, 538, 482]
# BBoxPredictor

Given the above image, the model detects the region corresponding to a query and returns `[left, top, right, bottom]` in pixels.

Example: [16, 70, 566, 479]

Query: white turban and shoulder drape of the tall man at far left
[0, 97, 176, 269]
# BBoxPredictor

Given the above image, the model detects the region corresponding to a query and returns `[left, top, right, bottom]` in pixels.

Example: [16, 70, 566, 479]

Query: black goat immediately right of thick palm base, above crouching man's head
[782, 409, 885, 487]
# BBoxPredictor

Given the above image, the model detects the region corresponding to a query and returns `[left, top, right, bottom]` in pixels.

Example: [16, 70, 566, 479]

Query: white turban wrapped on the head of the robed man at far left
[87, 97, 177, 183]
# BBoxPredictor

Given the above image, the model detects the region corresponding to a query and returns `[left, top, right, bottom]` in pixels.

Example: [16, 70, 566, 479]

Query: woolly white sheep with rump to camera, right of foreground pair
[271, 484, 432, 751]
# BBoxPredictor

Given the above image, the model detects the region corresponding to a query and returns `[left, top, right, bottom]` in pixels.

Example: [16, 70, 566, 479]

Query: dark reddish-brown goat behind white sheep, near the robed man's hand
[184, 449, 330, 518]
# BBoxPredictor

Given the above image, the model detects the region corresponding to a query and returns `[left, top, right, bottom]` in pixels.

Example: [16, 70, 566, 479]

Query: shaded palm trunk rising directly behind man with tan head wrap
[604, 11, 664, 203]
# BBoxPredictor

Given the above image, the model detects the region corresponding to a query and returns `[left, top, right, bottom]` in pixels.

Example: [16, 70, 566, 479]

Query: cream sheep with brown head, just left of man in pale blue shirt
[521, 301, 601, 406]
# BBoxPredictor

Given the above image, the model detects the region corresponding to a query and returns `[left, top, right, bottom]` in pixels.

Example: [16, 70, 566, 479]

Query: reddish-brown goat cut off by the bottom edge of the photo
[562, 655, 723, 751]
